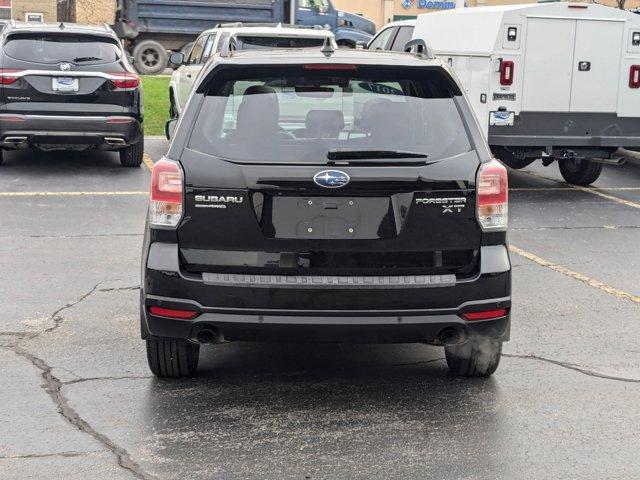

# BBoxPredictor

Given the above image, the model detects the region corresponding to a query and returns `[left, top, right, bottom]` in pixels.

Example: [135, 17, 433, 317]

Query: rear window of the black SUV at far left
[4, 33, 122, 65]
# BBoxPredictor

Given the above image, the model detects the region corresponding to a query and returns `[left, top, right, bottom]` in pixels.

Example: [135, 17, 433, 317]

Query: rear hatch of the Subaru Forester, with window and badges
[172, 64, 482, 309]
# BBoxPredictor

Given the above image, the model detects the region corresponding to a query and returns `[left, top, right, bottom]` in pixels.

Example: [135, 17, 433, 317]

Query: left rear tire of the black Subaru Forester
[147, 339, 200, 378]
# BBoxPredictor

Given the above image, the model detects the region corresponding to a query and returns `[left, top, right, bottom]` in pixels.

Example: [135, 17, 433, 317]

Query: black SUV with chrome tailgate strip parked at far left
[0, 21, 143, 167]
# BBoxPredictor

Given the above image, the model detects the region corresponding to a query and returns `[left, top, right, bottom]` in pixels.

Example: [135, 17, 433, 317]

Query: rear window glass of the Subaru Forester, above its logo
[190, 64, 471, 162]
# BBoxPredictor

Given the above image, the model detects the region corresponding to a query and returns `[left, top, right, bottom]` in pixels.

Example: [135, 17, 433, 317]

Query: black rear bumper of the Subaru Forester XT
[141, 243, 511, 343]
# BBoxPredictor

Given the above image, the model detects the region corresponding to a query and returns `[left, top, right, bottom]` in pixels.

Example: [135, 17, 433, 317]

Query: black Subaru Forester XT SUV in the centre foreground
[140, 43, 511, 377]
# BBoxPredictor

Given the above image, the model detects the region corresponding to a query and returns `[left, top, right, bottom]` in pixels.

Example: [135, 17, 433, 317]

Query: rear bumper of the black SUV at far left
[0, 113, 142, 150]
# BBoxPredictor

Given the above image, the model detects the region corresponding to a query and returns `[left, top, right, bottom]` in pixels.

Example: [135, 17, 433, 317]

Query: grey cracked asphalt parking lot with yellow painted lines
[0, 139, 640, 480]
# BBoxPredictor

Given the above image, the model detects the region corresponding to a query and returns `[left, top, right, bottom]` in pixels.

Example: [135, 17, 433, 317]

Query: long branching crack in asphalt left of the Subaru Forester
[8, 281, 156, 480]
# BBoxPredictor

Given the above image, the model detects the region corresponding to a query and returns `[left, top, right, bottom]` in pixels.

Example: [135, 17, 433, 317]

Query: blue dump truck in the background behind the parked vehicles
[113, 0, 375, 74]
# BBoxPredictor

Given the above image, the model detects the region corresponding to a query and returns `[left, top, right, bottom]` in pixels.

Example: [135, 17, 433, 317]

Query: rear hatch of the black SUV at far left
[0, 28, 140, 116]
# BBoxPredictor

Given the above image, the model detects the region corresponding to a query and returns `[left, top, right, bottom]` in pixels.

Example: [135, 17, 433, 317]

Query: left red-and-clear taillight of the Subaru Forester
[149, 159, 182, 228]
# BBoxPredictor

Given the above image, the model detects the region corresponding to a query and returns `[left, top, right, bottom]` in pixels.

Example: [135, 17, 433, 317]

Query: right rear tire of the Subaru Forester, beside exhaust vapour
[444, 337, 502, 377]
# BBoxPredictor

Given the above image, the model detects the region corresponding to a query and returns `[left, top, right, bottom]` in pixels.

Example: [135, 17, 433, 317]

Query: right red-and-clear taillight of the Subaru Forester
[476, 160, 509, 231]
